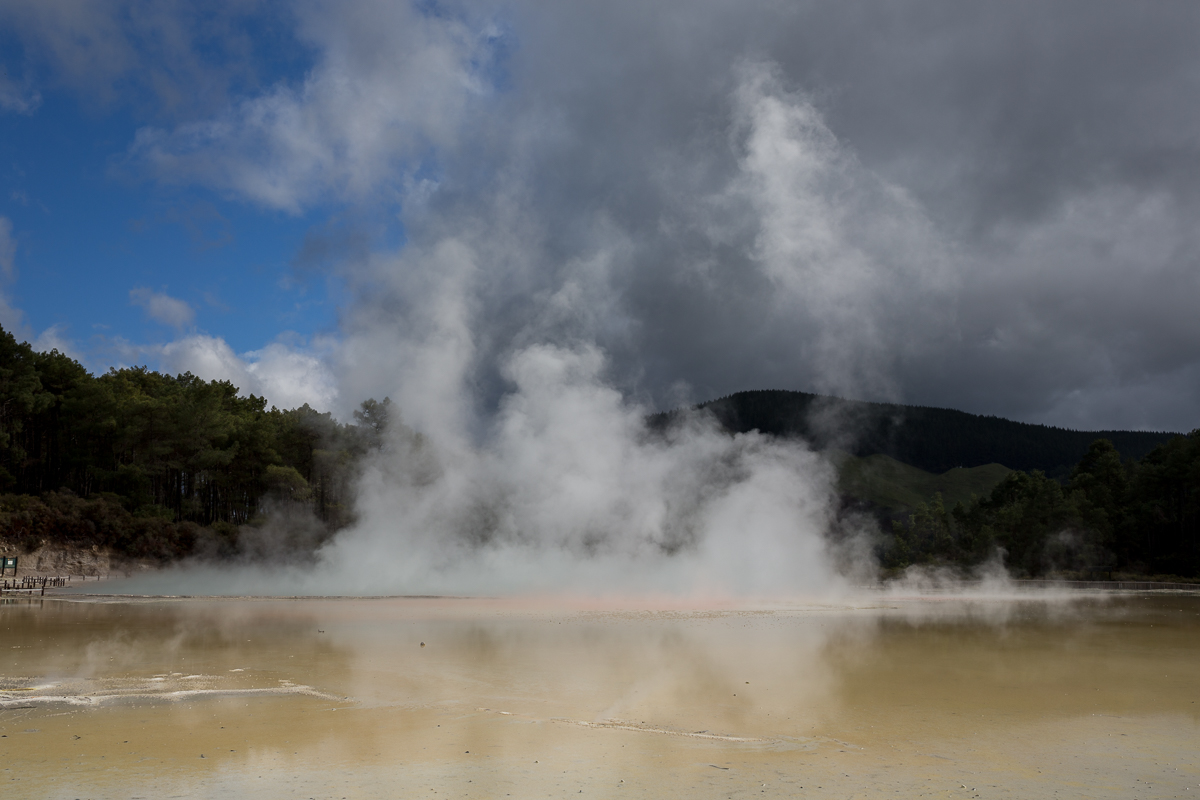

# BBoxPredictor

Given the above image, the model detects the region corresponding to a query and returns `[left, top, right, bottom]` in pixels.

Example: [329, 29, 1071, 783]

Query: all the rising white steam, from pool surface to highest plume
[108, 64, 960, 595]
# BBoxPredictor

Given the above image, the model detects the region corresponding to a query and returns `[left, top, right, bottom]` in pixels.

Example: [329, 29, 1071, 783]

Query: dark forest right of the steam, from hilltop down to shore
[667, 391, 1200, 577]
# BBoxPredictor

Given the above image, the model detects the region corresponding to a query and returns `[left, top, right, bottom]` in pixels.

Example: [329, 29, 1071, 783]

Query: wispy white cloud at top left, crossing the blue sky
[131, 2, 501, 212]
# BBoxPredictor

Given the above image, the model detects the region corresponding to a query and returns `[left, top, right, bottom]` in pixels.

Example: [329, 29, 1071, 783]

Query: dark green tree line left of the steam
[0, 329, 390, 559]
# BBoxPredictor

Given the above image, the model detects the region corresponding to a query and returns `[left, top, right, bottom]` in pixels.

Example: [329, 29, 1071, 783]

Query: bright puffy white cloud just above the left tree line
[156, 335, 338, 411]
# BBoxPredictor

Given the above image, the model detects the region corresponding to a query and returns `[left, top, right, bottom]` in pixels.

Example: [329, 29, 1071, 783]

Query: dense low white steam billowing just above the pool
[324, 344, 833, 594]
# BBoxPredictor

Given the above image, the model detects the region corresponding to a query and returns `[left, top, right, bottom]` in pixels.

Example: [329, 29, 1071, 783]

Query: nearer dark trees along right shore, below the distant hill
[878, 429, 1200, 578]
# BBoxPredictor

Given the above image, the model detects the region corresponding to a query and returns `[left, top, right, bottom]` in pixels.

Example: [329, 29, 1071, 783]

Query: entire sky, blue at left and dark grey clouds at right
[0, 0, 1200, 431]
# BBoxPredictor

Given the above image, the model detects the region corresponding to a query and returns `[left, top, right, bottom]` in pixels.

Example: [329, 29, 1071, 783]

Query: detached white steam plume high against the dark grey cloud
[722, 62, 955, 397]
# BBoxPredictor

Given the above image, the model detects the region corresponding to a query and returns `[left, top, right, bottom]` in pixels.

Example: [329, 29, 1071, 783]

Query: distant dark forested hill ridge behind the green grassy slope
[652, 391, 1177, 476]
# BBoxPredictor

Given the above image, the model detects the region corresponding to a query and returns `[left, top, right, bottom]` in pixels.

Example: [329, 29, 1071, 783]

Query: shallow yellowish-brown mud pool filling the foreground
[0, 595, 1200, 798]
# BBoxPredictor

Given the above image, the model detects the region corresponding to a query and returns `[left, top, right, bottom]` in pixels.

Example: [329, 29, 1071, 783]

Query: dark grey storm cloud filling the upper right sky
[384, 2, 1200, 429]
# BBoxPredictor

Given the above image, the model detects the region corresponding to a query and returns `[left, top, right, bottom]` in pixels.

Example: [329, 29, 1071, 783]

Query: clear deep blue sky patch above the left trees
[0, 33, 337, 368]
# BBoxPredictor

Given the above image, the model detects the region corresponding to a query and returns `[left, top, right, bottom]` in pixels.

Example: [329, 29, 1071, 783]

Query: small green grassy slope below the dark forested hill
[833, 451, 1012, 517]
